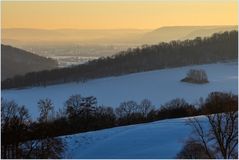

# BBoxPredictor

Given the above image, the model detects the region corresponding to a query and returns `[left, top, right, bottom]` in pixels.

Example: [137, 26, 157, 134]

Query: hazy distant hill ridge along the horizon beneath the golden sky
[2, 25, 238, 46]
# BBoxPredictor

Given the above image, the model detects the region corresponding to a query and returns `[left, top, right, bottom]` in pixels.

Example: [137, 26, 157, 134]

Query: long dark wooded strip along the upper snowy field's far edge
[2, 31, 238, 89]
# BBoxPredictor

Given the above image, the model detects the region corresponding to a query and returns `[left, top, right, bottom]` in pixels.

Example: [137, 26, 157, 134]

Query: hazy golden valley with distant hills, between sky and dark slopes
[2, 26, 237, 67]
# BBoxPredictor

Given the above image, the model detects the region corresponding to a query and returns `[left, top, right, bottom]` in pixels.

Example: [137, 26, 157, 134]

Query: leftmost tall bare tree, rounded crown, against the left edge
[1, 99, 31, 159]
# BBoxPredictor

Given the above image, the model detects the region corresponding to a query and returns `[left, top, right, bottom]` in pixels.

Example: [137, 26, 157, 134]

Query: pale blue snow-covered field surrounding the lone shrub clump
[2, 62, 238, 117]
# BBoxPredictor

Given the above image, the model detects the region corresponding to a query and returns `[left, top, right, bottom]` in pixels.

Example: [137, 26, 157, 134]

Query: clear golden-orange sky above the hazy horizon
[1, 0, 238, 29]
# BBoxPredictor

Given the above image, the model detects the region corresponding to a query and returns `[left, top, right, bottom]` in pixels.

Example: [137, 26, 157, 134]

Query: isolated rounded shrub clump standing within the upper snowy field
[181, 69, 209, 84]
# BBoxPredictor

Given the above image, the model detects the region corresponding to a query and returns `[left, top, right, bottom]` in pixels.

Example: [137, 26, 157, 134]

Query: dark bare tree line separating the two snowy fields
[1, 92, 238, 158]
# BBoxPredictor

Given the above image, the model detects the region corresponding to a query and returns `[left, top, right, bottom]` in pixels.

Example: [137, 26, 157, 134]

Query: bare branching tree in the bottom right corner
[189, 111, 238, 159]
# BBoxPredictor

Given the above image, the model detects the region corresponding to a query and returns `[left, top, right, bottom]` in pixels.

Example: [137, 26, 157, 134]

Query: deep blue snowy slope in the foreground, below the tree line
[63, 117, 205, 159]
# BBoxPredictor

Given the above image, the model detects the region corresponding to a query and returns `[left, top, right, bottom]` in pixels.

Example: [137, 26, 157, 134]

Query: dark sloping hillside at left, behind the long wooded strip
[1, 45, 57, 80]
